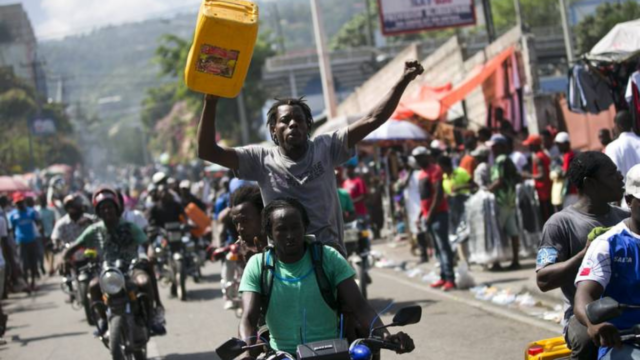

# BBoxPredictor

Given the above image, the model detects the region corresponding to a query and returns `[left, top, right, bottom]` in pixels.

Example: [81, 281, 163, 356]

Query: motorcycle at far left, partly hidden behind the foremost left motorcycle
[60, 249, 100, 326]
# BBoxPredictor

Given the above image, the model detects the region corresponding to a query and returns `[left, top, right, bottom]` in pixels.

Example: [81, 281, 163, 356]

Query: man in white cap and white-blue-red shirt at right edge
[575, 165, 640, 359]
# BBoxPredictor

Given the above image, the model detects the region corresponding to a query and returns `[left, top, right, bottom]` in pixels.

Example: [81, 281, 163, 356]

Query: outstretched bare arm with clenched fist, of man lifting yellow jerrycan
[349, 61, 424, 148]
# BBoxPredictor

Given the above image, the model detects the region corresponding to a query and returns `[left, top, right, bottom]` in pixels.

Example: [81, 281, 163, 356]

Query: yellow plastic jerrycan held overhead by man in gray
[184, 0, 258, 98]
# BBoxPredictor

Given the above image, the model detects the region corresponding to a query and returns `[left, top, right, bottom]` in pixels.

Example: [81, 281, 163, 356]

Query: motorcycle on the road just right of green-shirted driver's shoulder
[344, 219, 373, 299]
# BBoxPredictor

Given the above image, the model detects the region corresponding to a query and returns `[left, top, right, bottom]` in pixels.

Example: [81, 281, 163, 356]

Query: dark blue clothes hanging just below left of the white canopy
[569, 63, 613, 114]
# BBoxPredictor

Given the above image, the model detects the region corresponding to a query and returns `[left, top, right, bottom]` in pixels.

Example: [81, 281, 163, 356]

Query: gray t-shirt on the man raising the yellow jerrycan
[236, 128, 355, 246]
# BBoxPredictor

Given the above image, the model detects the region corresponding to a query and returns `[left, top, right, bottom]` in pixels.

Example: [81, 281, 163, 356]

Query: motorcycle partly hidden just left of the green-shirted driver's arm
[211, 243, 243, 319]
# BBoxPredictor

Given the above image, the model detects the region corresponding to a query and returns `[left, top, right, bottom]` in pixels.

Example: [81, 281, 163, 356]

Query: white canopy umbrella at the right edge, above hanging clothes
[587, 20, 640, 61]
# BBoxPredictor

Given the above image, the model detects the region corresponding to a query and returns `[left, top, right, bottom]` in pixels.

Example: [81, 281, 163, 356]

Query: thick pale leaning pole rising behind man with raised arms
[311, 0, 338, 120]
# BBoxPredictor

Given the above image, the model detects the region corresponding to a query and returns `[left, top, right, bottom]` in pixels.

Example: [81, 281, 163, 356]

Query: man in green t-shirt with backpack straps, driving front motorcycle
[240, 199, 414, 359]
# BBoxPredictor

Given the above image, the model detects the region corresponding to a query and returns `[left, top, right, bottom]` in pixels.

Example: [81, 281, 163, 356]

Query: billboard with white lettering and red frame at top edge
[378, 0, 476, 36]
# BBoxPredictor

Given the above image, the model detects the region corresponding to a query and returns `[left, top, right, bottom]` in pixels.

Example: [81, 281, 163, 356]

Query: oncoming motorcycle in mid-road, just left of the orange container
[150, 223, 204, 301]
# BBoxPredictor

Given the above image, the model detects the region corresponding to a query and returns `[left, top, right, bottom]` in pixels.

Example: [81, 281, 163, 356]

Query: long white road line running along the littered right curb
[373, 269, 562, 334]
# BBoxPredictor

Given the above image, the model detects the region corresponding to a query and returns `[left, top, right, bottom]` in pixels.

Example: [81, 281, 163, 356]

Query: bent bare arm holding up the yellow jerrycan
[198, 95, 240, 170]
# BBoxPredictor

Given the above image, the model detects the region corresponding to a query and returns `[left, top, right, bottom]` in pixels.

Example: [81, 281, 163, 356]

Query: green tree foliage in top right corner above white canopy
[574, 0, 640, 53]
